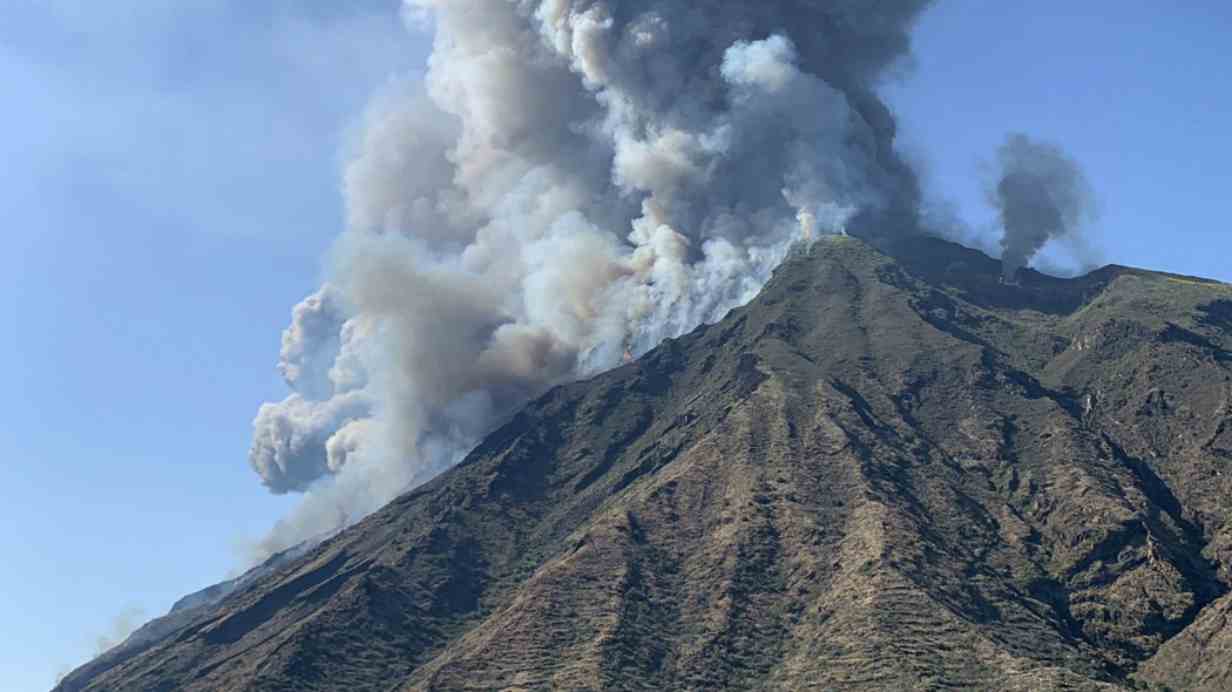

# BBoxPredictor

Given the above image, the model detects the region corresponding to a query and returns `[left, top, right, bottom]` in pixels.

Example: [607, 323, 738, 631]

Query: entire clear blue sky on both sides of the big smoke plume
[0, 0, 1232, 692]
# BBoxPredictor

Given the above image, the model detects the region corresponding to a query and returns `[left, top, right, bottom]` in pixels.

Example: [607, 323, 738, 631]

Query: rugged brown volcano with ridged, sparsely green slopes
[58, 238, 1232, 692]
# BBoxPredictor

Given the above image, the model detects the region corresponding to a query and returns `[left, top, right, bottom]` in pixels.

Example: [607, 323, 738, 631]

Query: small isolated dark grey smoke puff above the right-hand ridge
[992, 134, 1094, 280]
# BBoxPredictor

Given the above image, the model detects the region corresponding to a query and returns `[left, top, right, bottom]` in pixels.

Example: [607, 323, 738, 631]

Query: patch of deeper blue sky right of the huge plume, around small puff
[887, 0, 1232, 281]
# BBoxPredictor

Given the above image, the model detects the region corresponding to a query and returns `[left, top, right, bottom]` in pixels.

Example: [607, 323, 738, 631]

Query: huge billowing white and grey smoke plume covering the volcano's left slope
[242, 0, 930, 558]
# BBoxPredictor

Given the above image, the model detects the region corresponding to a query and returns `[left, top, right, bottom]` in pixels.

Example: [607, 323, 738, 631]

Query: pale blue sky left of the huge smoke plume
[0, 0, 426, 691]
